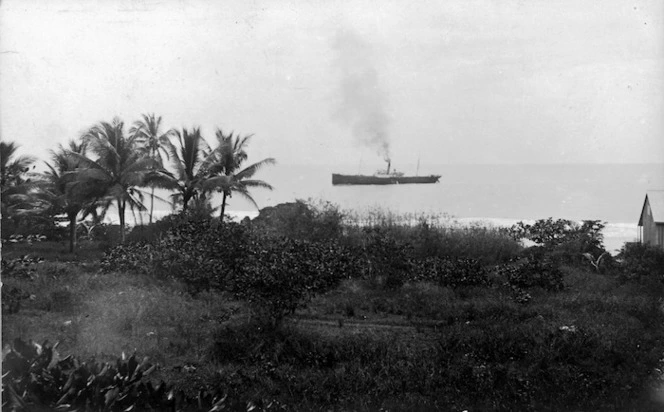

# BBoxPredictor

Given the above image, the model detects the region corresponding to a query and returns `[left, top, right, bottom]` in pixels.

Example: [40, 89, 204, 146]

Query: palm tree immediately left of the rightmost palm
[153, 128, 210, 212]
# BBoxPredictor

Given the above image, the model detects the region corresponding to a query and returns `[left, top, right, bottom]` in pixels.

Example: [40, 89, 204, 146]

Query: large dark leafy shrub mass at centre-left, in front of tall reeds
[101, 212, 353, 324]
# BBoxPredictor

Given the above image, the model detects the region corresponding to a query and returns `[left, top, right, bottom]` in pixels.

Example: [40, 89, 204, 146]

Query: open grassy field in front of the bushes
[2, 242, 664, 411]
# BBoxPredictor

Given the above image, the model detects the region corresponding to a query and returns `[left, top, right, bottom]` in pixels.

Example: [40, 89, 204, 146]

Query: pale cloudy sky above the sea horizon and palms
[0, 0, 664, 169]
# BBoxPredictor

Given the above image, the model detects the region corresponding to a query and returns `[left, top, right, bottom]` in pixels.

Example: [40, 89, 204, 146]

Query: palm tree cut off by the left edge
[0, 142, 35, 216]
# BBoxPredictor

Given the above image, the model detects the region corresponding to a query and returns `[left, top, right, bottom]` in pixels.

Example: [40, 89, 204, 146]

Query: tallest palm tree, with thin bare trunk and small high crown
[129, 113, 176, 224]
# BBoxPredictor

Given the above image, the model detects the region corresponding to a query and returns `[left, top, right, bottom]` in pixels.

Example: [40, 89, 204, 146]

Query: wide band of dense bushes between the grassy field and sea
[102, 208, 661, 330]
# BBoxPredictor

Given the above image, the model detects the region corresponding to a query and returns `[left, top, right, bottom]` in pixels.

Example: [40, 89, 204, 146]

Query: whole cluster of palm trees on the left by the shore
[1, 114, 275, 248]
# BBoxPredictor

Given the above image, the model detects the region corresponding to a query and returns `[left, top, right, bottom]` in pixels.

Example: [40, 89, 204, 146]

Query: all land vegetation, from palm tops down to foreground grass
[2, 121, 664, 411]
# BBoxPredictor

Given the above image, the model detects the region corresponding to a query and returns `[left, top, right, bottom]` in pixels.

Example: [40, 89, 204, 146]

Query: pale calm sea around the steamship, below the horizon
[122, 164, 664, 251]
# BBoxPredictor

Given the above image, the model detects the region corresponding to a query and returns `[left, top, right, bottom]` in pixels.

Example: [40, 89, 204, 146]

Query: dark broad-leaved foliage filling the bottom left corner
[2, 339, 278, 411]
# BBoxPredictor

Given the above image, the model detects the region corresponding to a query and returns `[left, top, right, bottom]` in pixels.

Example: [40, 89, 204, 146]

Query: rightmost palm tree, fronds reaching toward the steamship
[202, 129, 276, 219]
